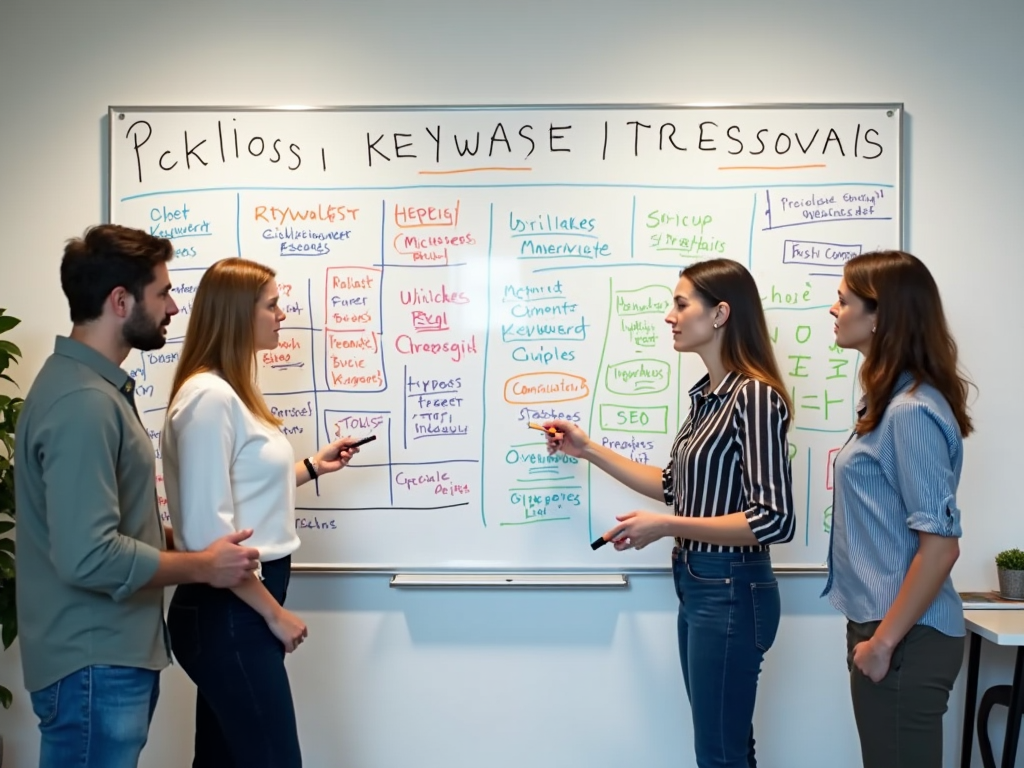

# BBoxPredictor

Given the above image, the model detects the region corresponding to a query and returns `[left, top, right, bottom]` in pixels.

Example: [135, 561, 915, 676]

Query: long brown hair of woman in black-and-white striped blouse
[679, 259, 793, 419]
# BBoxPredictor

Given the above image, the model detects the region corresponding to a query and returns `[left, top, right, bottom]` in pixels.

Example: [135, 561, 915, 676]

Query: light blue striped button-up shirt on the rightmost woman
[821, 373, 965, 637]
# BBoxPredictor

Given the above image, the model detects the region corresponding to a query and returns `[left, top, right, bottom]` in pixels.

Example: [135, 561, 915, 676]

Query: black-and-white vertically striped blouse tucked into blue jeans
[662, 373, 796, 552]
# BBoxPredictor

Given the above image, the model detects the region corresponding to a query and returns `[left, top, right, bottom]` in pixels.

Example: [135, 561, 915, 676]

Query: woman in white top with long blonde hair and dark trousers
[161, 258, 358, 768]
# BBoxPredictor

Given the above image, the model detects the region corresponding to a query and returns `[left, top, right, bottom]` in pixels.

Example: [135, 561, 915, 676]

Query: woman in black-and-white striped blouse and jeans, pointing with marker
[542, 259, 795, 768]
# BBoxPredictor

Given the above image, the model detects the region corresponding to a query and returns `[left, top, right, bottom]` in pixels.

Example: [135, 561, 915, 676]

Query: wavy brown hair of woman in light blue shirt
[843, 251, 974, 437]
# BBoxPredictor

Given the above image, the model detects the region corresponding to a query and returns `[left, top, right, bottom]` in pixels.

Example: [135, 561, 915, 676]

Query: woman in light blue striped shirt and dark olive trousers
[823, 251, 972, 768]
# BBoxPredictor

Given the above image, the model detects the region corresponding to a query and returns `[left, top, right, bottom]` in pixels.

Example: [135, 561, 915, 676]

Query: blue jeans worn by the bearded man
[31, 665, 160, 768]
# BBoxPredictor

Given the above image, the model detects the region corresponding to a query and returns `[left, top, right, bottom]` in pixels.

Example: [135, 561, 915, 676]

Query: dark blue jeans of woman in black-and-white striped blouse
[672, 549, 781, 768]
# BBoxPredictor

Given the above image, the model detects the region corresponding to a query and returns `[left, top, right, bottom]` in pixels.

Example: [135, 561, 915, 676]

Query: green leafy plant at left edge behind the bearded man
[0, 308, 23, 716]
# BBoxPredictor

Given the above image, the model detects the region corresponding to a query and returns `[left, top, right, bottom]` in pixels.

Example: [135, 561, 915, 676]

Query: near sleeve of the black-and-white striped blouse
[736, 380, 796, 545]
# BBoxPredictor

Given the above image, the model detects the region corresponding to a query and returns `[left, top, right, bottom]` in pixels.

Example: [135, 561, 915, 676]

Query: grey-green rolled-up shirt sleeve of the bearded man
[39, 389, 160, 601]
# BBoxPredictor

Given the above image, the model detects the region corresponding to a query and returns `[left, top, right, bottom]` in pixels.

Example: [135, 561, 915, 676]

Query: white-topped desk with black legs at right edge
[961, 605, 1024, 768]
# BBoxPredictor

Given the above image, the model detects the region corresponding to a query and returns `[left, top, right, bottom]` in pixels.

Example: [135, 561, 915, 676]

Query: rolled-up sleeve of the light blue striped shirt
[889, 402, 963, 538]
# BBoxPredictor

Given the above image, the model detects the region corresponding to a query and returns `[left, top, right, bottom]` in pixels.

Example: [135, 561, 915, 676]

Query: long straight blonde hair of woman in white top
[171, 258, 283, 427]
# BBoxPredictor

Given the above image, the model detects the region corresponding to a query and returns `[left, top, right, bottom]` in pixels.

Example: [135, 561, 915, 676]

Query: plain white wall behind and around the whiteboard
[0, 0, 1024, 768]
